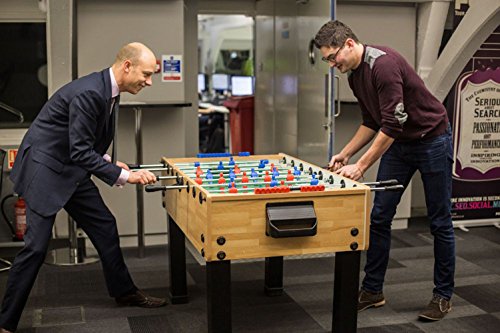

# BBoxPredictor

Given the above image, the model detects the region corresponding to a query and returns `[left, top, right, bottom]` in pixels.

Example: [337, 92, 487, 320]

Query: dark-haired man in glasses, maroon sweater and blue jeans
[315, 21, 455, 320]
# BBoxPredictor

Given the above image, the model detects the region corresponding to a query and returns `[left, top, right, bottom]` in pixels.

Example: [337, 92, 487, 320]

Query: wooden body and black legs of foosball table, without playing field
[163, 154, 371, 333]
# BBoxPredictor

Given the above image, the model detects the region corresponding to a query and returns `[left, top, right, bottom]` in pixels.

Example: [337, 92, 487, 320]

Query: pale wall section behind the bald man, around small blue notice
[77, 0, 198, 246]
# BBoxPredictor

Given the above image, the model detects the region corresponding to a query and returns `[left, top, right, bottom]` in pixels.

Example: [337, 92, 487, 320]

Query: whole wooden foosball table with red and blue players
[146, 154, 399, 332]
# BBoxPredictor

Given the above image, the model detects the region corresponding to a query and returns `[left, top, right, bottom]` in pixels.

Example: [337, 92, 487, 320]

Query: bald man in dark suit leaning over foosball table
[0, 43, 166, 332]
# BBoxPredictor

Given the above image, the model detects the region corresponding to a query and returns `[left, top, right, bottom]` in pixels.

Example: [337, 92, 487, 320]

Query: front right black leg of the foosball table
[332, 251, 361, 333]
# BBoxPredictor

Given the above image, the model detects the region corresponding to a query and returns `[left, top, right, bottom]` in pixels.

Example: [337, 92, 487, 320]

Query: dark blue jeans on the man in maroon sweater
[362, 126, 455, 300]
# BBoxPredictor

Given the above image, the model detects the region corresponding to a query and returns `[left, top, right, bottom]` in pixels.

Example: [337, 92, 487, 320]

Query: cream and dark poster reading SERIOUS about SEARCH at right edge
[451, 68, 500, 220]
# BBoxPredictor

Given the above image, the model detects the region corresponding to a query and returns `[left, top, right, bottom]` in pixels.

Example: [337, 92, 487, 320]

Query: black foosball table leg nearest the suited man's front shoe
[167, 214, 188, 304]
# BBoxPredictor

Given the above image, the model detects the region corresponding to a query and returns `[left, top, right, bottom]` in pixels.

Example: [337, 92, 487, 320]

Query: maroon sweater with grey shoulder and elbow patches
[349, 45, 448, 141]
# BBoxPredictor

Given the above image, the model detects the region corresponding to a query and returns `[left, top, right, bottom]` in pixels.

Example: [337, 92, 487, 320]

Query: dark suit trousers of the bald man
[0, 178, 137, 331]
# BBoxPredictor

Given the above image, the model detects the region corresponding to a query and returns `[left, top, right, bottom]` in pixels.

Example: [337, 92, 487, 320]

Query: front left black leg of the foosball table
[207, 260, 231, 333]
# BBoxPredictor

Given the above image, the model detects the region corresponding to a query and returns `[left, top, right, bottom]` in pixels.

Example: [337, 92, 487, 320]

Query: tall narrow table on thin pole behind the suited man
[119, 101, 192, 258]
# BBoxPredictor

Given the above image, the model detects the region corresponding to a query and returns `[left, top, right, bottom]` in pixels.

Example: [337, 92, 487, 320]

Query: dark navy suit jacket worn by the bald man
[10, 68, 121, 216]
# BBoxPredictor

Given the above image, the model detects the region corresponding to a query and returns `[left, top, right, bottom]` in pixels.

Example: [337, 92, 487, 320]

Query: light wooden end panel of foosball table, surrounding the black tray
[205, 191, 369, 261]
